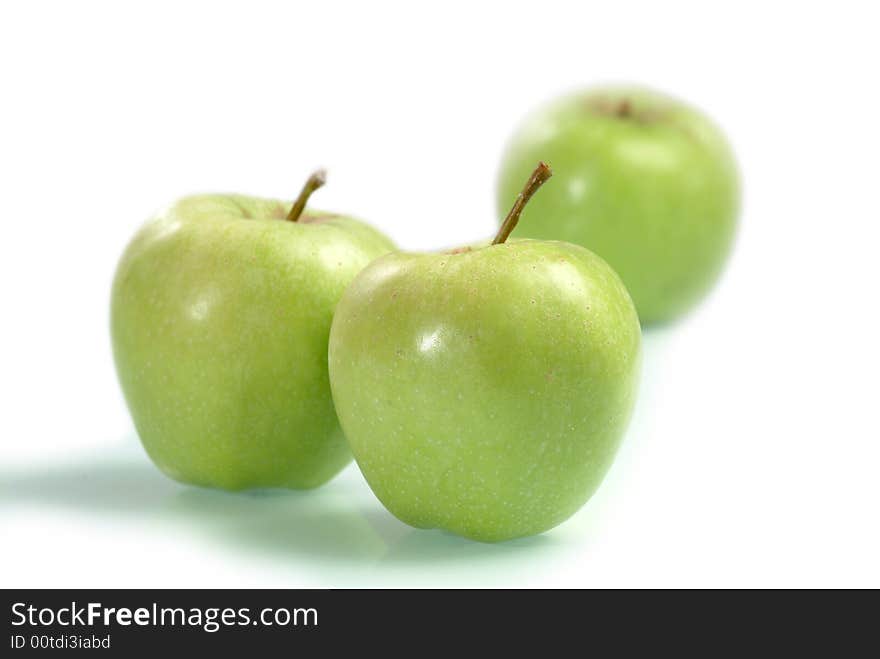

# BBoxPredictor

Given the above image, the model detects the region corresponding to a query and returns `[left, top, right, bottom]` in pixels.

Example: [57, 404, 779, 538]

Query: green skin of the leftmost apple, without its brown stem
[111, 195, 392, 490]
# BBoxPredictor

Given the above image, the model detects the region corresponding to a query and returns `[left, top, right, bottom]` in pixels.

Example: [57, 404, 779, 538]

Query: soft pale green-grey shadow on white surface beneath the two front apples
[0, 447, 554, 567]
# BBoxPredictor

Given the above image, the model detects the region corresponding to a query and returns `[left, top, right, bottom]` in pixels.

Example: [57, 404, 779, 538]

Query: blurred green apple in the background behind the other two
[497, 87, 740, 324]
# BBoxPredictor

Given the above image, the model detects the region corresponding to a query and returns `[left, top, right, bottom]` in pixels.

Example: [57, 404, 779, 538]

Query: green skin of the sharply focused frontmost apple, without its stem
[329, 240, 641, 542]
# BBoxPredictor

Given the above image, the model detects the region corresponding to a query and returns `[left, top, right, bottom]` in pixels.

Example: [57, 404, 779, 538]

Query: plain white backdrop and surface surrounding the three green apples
[0, 0, 880, 587]
